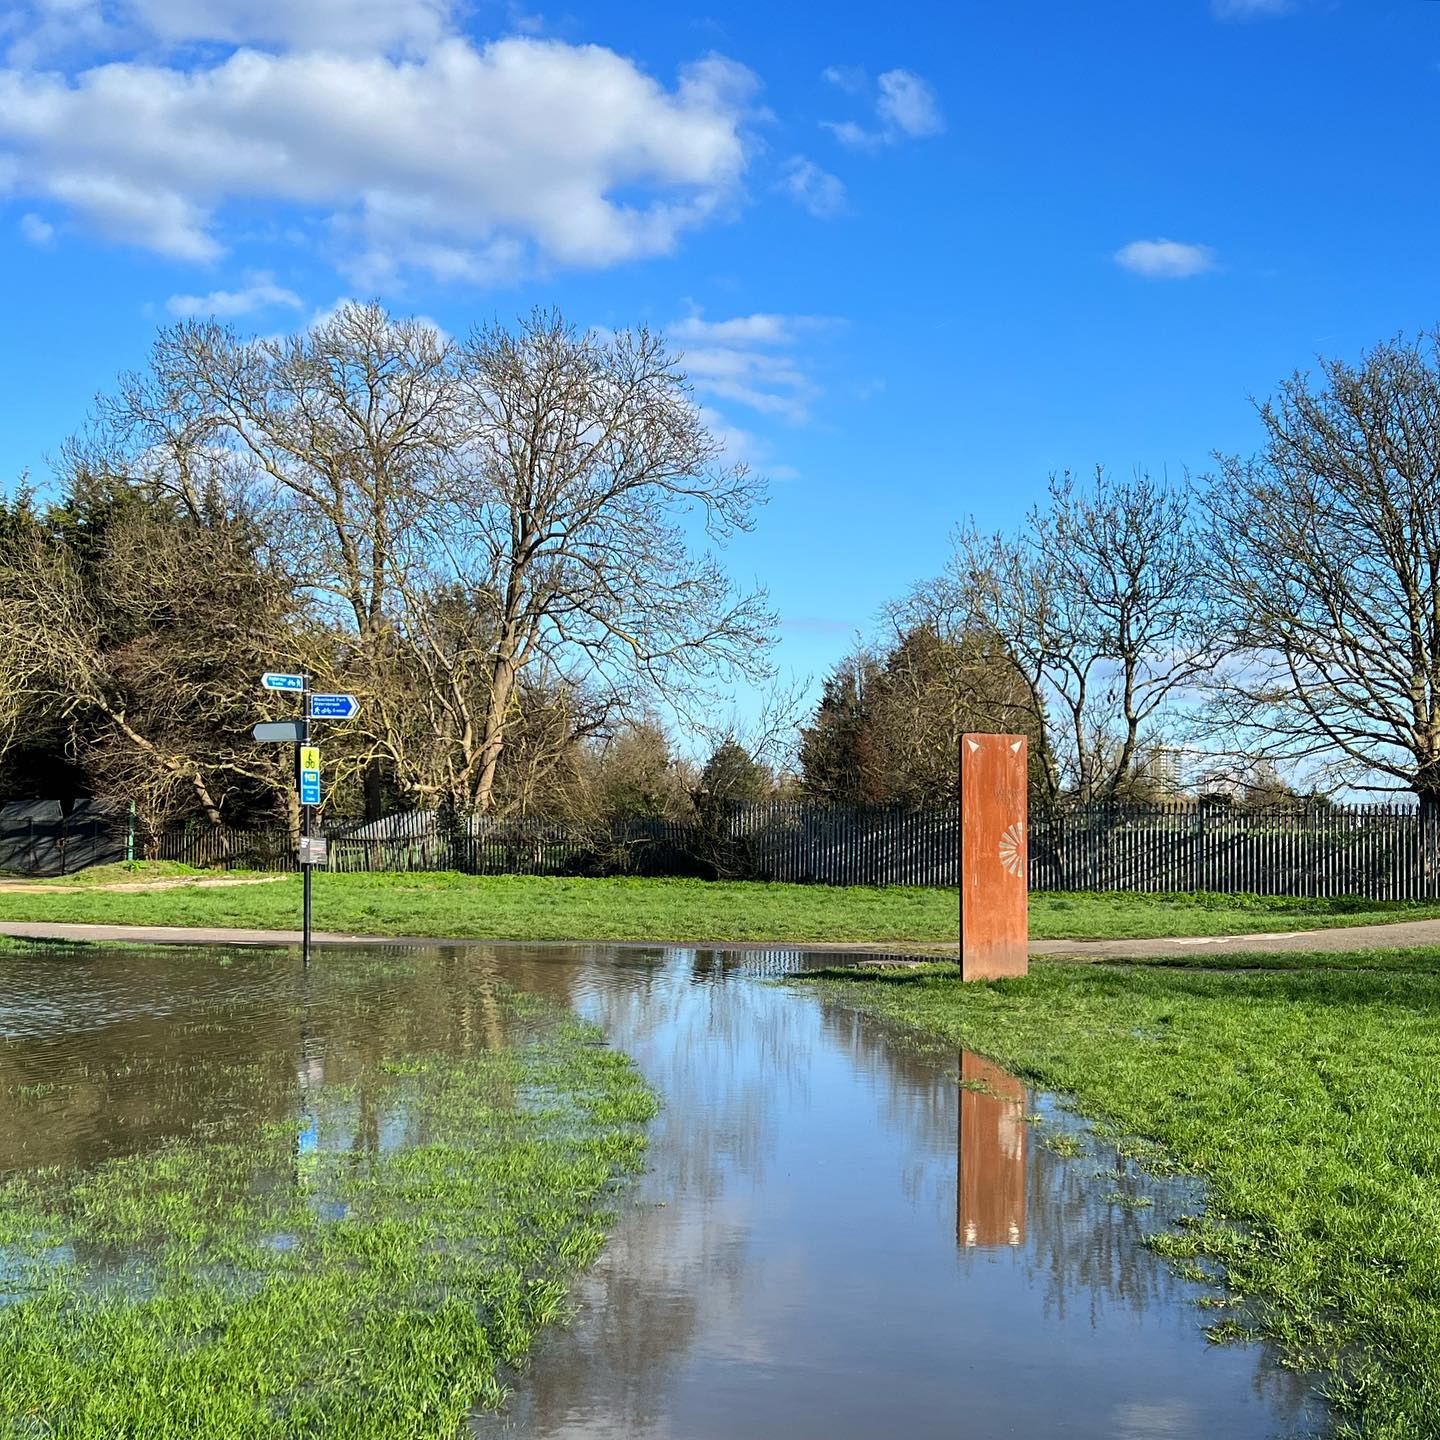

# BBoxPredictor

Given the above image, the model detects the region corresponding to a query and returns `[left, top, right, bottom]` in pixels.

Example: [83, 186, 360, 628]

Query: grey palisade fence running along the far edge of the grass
[25, 801, 1440, 900]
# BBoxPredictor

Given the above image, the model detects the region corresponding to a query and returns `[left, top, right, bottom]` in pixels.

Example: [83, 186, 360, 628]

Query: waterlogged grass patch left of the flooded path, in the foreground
[0, 992, 655, 1440]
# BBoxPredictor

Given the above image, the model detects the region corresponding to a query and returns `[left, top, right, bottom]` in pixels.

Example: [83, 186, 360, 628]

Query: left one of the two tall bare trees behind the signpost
[116, 304, 455, 815]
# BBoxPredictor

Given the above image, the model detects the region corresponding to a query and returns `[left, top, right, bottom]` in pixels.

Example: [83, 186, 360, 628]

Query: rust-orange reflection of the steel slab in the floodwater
[955, 1051, 1030, 1250]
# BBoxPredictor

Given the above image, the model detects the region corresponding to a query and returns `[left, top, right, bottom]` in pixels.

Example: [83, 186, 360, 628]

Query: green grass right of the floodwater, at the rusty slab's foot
[815, 949, 1440, 1440]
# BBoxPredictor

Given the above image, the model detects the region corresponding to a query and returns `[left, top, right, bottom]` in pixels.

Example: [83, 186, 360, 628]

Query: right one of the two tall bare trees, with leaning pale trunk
[435, 311, 773, 809]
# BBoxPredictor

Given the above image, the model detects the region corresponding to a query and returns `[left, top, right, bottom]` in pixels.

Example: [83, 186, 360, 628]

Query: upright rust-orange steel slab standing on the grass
[960, 734, 1030, 981]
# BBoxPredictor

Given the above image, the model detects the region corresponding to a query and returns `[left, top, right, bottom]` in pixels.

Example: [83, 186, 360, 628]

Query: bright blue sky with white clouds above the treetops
[0, 0, 1440, 720]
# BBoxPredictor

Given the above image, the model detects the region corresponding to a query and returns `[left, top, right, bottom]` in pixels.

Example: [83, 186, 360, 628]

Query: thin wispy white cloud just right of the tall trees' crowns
[667, 312, 832, 422]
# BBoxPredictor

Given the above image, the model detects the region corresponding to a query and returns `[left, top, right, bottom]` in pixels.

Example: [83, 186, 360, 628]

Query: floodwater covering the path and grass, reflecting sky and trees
[0, 946, 1325, 1440]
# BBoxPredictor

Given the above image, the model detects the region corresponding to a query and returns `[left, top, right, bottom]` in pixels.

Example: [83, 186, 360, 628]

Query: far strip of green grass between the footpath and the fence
[0, 865, 1440, 948]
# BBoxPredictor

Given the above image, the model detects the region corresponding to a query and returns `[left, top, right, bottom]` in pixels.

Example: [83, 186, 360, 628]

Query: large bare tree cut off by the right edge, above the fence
[1208, 334, 1440, 809]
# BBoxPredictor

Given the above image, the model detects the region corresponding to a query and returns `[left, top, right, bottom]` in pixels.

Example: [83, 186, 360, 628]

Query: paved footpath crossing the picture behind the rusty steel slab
[8, 920, 1440, 963]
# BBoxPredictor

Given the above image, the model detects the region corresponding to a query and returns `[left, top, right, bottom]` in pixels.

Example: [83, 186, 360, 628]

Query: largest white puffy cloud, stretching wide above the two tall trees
[0, 37, 755, 284]
